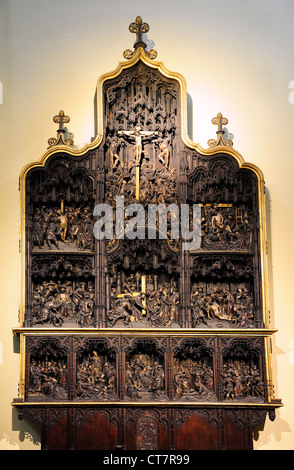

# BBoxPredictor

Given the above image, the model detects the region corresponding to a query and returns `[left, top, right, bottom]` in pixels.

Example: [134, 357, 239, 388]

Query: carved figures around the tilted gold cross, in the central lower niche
[107, 274, 179, 327]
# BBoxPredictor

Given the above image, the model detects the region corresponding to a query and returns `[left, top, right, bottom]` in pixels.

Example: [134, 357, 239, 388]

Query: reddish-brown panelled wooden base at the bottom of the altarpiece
[18, 405, 271, 451]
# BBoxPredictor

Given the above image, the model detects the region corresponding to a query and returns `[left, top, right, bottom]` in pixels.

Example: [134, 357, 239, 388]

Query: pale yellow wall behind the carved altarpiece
[0, 0, 294, 450]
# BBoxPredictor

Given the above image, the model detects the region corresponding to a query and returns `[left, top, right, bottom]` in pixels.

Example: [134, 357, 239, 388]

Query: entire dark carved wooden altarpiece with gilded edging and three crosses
[13, 17, 282, 450]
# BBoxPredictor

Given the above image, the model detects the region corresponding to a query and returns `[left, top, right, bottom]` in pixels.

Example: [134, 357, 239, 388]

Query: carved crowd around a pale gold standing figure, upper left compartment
[29, 206, 94, 251]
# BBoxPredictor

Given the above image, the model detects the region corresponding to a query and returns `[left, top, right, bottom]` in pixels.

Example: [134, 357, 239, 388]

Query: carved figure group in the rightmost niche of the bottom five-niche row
[222, 359, 264, 400]
